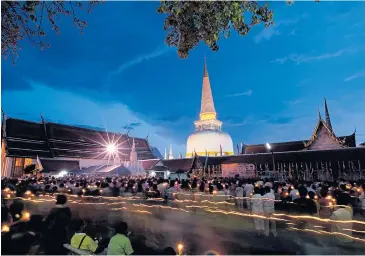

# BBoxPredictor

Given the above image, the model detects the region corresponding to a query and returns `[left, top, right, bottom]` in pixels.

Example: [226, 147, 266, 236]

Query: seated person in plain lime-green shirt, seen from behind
[108, 222, 134, 255]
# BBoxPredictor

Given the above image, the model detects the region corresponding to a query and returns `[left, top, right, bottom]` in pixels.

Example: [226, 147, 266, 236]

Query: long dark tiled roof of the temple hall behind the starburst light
[4, 118, 155, 160]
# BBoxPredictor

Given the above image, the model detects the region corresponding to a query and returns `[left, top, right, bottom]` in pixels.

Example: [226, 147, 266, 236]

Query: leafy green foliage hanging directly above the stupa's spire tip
[157, 1, 274, 58]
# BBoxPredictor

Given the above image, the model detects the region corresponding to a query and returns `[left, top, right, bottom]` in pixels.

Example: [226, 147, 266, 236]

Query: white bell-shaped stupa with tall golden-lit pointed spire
[186, 58, 234, 158]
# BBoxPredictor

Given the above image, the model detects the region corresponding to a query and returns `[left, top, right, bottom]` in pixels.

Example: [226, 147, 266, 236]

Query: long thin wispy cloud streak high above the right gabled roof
[271, 48, 361, 64]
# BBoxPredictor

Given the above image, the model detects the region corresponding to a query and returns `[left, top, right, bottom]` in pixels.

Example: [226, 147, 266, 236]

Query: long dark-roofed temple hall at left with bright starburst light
[1, 114, 158, 177]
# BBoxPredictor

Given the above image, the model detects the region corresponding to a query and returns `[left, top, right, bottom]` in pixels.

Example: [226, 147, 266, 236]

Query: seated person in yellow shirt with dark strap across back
[71, 220, 98, 253]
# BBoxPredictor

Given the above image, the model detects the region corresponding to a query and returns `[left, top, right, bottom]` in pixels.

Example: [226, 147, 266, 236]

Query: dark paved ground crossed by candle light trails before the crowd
[21, 196, 365, 255]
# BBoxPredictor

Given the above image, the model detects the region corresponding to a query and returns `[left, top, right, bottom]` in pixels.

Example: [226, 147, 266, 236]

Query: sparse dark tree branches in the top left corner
[1, 1, 99, 62]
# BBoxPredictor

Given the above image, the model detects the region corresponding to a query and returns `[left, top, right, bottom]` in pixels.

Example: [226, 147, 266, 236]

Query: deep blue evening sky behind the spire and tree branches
[1, 1, 365, 156]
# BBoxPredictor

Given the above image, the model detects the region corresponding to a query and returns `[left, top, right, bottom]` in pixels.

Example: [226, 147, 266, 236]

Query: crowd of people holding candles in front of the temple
[1, 175, 365, 255]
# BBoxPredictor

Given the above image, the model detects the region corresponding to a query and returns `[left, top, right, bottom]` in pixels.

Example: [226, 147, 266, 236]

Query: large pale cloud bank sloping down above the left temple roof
[2, 82, 185, 157]
